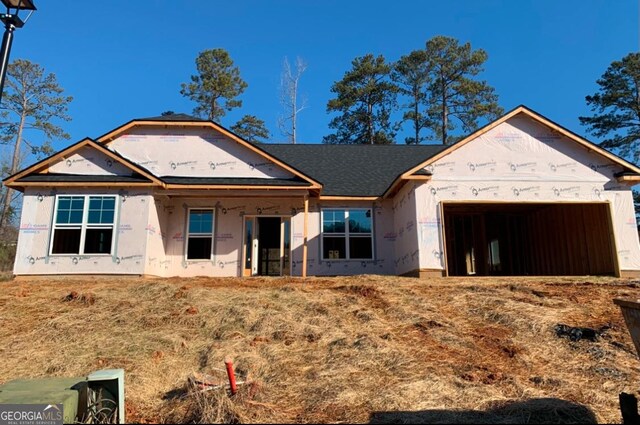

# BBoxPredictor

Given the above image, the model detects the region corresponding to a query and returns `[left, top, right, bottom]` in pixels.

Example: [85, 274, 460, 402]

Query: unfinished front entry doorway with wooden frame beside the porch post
[243, 216, 291, 276]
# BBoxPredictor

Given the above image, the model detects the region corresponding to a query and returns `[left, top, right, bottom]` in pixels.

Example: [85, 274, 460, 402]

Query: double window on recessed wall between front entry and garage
[322, 209, 373, 260]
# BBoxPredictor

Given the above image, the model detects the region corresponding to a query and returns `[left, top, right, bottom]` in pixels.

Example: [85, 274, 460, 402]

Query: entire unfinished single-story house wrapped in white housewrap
[4, 106, 640, 276]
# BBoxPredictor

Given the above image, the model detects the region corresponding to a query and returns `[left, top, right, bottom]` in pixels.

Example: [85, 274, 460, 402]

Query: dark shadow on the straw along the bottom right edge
[369, 398, 598, 424]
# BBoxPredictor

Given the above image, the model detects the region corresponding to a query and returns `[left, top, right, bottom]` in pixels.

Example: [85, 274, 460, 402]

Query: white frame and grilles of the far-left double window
[48, 193, 120, 257]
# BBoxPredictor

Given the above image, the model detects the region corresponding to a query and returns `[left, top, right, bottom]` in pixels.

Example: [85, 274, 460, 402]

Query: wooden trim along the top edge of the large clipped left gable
[98, 117, 322, 189]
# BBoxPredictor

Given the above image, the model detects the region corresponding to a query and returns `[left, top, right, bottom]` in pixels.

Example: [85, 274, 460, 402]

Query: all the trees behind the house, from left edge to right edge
[0, 36, 640, 238]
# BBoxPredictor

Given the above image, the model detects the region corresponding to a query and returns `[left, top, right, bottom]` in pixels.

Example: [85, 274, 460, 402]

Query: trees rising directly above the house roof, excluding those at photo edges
[181, 36, 503, 144]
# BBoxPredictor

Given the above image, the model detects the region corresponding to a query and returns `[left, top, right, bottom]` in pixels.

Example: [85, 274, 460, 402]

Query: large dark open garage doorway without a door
[443, 203, 616, 276]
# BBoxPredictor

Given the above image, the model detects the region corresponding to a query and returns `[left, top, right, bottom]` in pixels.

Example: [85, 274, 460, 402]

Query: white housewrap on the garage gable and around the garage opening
[410, 116, 640, 270]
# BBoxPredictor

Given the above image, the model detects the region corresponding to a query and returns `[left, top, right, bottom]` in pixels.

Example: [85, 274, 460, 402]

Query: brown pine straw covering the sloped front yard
[0, 276, 640, 423]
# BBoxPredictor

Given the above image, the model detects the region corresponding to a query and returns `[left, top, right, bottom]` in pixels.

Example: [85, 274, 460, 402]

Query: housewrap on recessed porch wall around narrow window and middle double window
[145, 197, 395, 276]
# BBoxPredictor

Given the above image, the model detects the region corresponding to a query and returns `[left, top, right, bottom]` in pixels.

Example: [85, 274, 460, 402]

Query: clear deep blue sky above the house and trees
[6, 0, 638, 149]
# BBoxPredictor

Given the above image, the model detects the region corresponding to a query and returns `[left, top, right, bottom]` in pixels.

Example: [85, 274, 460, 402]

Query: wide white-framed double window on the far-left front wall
[51, 195, 116, 255]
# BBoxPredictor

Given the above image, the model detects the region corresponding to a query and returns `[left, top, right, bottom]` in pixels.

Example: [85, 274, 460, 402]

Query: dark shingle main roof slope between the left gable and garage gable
[258, 144, 447, 196]
